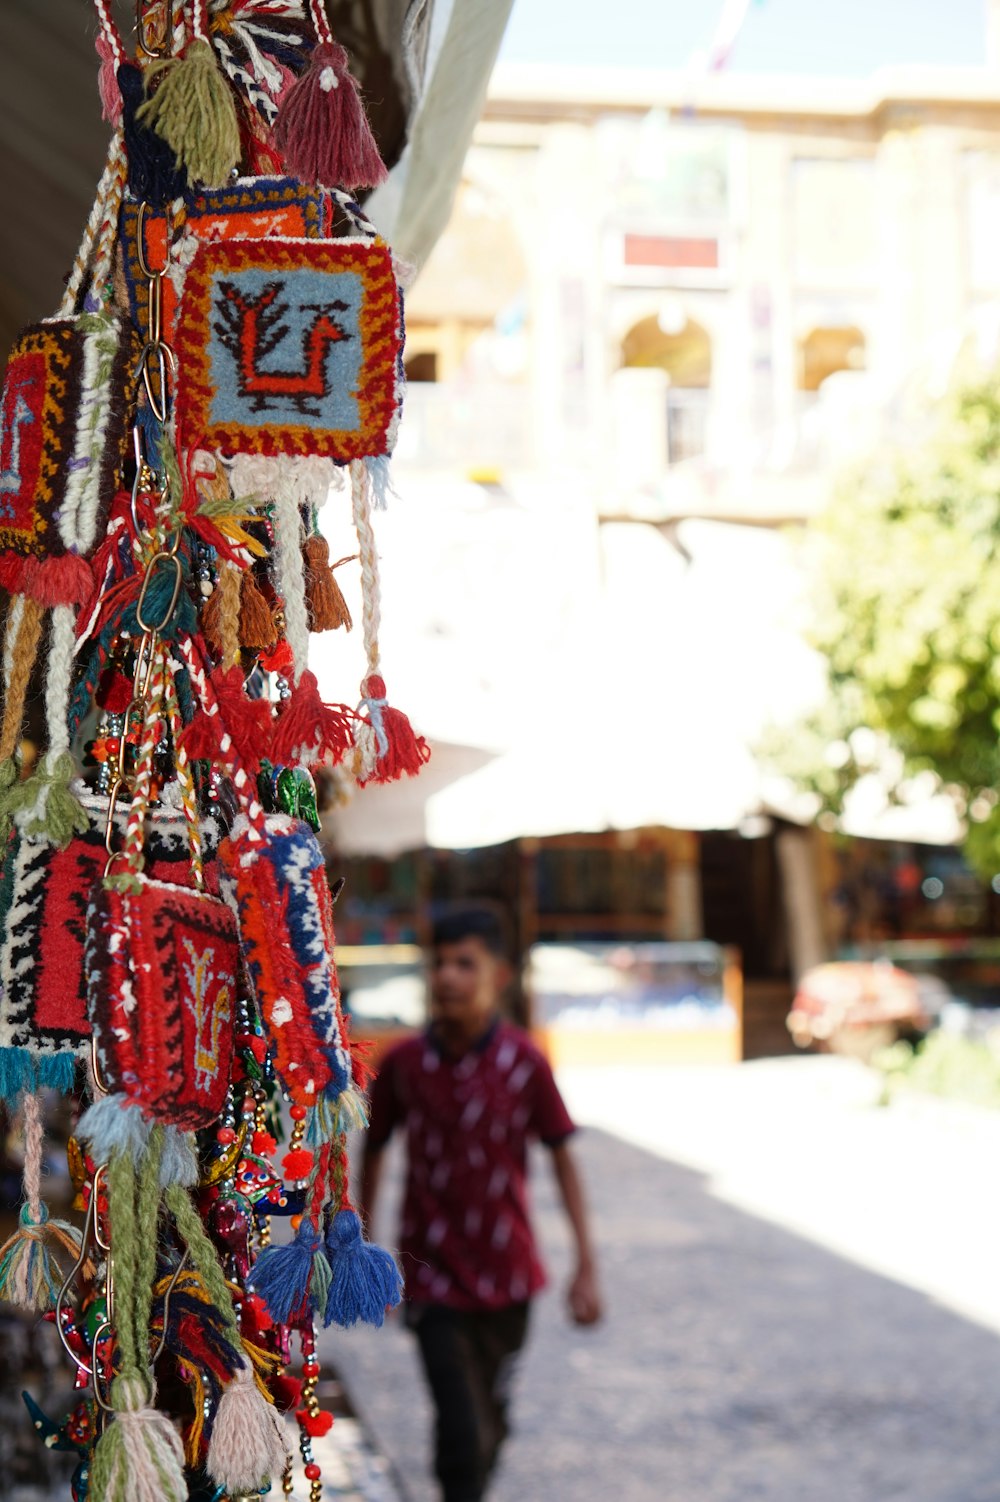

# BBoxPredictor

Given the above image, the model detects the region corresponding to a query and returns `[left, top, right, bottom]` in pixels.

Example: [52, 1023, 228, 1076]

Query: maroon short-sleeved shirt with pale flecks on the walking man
[361, 1021, 574, 1310]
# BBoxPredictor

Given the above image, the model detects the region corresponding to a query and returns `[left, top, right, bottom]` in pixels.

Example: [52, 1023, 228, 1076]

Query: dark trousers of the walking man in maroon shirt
[407, 1304, 529, 1502]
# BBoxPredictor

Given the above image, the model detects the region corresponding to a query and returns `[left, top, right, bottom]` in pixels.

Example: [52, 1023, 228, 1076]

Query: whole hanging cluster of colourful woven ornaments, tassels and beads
[0, 0, 426, 1502]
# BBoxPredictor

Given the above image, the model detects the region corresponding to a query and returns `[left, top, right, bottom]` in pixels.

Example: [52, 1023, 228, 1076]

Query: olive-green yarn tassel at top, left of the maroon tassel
[137, 39, 240, 188]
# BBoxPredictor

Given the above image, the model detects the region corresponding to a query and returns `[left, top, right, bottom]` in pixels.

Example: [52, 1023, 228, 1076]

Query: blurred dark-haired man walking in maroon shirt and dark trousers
[360, 907, 601, 1502]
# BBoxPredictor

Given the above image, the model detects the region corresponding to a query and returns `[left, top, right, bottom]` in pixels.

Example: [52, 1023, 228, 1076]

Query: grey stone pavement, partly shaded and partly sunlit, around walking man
[326, 1059, 1000, 1502]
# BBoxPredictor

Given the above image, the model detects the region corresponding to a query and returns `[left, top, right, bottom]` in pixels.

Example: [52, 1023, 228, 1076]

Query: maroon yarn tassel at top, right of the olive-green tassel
[273, 42, 389, 191]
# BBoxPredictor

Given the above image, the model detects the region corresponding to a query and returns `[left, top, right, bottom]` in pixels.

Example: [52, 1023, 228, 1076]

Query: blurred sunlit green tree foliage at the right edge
[781, 374, 1000, 876]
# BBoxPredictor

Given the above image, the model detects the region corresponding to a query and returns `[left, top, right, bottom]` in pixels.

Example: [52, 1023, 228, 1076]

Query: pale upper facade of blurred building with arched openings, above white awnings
[405, 68, 1000, 521]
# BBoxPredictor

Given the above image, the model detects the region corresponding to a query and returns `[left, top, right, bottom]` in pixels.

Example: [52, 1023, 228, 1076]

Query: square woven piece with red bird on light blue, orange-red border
[177, 239, 401, 463]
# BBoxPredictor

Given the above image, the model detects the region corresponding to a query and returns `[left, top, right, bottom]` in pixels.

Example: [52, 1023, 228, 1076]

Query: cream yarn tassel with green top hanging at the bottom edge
[89, 1371, 188, 1502]
